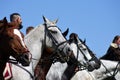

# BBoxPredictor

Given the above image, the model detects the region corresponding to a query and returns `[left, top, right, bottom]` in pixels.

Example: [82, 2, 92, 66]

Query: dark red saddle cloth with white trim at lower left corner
[3, 63, 12, 80]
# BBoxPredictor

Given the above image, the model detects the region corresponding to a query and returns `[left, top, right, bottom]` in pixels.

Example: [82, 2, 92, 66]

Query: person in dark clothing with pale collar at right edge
[101, 35, 120, 61]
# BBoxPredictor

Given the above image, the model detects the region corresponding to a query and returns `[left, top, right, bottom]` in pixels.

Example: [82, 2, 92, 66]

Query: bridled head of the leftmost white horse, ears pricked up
[43, 16, 72, 62]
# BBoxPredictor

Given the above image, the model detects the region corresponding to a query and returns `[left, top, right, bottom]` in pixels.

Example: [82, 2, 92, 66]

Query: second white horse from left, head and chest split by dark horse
[46, 33, 100, 80]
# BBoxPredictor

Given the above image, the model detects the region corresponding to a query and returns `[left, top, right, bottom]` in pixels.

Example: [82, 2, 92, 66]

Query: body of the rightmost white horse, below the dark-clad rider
[71, 60, 120, 80]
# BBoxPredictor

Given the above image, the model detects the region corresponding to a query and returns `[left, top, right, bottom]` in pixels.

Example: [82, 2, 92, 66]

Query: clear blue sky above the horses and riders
[0, 0, 120, 57]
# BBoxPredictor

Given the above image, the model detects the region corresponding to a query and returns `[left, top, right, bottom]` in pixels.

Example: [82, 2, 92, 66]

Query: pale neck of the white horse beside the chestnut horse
[25, 25, 45, 69]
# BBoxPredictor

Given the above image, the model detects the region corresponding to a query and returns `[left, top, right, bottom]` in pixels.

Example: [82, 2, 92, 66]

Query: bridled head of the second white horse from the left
[69, 33, 101, 71]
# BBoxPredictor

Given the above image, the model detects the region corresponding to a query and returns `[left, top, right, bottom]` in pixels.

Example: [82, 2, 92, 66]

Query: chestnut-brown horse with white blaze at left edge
[0, 18, 30, 80]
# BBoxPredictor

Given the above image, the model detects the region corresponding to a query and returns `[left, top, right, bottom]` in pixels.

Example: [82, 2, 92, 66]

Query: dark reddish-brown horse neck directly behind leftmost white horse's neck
[35, 49, 52, 80]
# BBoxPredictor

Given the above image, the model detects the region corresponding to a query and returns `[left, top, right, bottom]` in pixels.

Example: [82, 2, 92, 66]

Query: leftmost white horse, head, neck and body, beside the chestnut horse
[12, 17, 72, 80]
